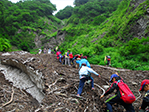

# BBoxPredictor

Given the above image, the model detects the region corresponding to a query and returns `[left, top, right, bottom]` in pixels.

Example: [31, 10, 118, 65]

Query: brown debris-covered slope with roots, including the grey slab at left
[0, 51, 149, 112]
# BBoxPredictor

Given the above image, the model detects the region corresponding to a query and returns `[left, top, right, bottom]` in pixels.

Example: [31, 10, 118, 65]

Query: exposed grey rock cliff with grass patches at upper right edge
[128, 0, 149, 38]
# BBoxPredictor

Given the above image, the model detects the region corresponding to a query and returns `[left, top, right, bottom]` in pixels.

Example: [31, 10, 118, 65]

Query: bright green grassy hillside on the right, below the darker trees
[60, 0, 149, 70]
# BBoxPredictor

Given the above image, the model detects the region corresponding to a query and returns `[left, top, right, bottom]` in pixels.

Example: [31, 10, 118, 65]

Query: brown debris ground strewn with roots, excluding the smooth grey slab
[0, 52, 149, 112]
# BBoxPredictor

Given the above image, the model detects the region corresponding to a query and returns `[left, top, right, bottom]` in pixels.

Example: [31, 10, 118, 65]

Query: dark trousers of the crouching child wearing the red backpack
[106, 95, 135, 112]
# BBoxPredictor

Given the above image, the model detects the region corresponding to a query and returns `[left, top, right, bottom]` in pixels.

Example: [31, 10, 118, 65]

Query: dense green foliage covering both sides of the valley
[0, 0, 149, 70]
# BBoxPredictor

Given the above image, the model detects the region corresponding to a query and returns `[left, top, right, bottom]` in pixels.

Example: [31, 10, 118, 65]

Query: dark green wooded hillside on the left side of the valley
[0, 0, 60, 51]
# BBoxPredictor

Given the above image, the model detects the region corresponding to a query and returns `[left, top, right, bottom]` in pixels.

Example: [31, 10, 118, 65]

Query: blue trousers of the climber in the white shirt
[77, 76, 94, 95]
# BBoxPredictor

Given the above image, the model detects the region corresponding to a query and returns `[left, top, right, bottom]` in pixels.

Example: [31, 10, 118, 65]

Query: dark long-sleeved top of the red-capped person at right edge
[141, 90, 149, 110]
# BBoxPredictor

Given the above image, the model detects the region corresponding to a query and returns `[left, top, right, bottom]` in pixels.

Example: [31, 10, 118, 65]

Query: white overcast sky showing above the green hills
[9, 0, 75, 14]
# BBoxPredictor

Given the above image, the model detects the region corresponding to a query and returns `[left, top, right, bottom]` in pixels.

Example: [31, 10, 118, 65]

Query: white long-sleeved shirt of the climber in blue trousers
[79, 66, 99, 79]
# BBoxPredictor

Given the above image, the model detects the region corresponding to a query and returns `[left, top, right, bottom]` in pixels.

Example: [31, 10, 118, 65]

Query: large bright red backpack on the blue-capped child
[115, 80, 136, 104]
